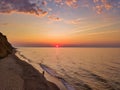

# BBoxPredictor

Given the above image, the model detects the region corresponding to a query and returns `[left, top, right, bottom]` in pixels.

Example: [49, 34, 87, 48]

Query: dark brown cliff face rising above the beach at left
[0, 32, 13, 59]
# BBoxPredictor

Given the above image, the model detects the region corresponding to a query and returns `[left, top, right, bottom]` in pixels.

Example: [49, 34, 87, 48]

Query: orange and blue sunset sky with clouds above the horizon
[0, 0, 120, 47]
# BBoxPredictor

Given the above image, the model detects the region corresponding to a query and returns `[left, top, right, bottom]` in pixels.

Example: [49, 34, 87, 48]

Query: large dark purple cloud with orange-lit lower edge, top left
[0, 0, 48, 16]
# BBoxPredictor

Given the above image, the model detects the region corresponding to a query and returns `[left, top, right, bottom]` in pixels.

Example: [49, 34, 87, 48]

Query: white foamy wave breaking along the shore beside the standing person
[40, 63, 75, 90]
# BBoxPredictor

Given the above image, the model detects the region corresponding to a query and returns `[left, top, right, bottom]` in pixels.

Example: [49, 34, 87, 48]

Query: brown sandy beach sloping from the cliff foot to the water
[0, 50, 60, 90]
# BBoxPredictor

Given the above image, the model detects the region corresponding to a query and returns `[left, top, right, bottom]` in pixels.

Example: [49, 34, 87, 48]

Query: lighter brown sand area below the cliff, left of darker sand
[0, 55, 24, 90]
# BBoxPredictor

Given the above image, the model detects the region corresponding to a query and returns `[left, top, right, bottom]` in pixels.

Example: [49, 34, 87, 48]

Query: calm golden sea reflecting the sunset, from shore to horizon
[18, 48, 120, 90]
